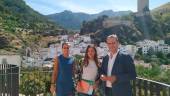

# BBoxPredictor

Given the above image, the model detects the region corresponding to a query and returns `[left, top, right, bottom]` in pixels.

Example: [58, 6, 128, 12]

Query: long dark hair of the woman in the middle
[83, 45, 99, 67]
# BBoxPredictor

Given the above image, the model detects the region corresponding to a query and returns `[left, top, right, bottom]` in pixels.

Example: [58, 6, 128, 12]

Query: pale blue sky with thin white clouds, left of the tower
[25, 0, 137, 15]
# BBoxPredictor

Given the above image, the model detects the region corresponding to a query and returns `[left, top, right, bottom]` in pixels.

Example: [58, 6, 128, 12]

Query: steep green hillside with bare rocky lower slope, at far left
[0, 0, 63, 52]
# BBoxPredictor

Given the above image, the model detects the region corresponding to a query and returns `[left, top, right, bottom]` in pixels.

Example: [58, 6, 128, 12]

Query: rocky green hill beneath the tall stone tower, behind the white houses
[80, 3, 170, 44]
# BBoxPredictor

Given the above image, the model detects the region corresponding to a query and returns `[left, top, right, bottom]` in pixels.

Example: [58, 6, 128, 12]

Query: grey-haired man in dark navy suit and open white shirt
[100, 34, 136, 96]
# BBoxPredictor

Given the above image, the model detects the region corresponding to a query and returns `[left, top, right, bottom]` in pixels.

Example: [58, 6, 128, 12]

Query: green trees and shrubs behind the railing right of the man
[135, 48, 170, 84]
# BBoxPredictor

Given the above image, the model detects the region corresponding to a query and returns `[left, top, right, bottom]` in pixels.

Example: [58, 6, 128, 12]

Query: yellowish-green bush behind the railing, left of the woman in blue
[19, 68, 51, 96]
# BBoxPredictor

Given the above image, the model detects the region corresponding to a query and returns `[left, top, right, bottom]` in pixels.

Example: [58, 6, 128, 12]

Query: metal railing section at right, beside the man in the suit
[133, 77, 170, 96]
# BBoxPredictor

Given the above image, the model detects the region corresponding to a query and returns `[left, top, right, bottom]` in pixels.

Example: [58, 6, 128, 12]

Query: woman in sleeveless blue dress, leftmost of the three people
[50, 43, 74, 96]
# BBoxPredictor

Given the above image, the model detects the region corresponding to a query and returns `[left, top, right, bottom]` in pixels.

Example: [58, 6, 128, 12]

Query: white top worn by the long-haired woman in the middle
[82, 60, 98, 81]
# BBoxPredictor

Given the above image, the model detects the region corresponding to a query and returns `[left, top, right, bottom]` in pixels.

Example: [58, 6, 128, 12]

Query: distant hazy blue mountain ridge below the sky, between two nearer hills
[46, 10, 131, 29]
